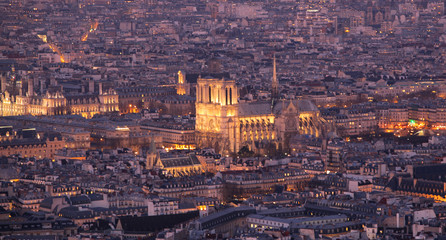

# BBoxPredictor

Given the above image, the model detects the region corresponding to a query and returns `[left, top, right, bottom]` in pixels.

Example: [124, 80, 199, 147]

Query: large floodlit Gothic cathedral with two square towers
[195, 77, 324, 154]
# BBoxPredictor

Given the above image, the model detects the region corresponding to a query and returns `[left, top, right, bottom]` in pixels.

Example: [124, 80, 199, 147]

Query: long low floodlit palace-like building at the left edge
[0, 89, 119, 118]
